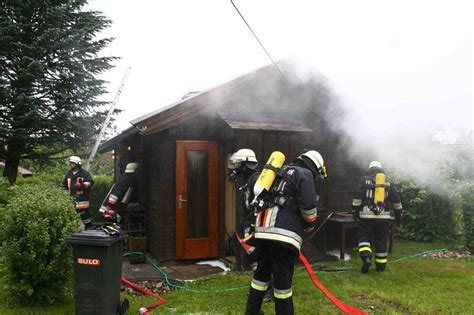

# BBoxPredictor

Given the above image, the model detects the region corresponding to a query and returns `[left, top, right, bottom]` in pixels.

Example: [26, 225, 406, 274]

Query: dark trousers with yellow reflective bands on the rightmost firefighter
[358, 219, 390, 271]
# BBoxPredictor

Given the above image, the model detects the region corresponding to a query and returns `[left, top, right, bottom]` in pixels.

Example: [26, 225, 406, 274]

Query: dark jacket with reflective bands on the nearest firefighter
[249, 165, 319, 253]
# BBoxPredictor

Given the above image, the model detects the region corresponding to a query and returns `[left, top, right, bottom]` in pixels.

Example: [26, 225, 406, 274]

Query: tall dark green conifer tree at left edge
[0, 0, 116, 184]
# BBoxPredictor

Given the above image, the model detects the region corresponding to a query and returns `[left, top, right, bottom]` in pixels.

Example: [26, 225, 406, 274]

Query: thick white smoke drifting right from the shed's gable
[204, 55, 474, 193]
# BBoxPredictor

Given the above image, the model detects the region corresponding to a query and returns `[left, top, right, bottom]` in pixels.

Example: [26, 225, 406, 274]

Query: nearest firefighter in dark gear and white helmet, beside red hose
[246, 151, 326, 314]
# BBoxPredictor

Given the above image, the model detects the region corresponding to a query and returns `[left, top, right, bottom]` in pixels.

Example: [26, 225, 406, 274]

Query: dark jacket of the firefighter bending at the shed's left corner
[105, 173, 138, 213]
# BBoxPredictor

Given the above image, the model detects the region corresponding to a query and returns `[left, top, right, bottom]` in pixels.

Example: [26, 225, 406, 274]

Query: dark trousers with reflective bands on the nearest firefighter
[245, 240, 296, 315]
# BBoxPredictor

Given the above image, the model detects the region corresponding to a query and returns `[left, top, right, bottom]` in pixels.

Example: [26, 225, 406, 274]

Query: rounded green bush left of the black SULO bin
[0, 183, 80, 304]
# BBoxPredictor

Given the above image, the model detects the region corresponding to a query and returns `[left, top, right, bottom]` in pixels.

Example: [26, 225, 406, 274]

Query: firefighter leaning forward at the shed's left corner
[99, 162, 139, 223]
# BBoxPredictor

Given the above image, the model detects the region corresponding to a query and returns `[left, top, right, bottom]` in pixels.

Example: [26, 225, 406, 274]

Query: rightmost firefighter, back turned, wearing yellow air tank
[352, 161, 402, 273]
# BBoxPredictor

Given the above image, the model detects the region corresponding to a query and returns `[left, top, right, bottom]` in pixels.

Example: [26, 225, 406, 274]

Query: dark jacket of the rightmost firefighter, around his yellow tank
[352, 170, 402, 220]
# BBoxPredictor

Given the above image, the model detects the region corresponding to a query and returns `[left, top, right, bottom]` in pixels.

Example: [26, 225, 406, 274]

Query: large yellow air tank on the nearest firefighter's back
[252, 151, 285, 206]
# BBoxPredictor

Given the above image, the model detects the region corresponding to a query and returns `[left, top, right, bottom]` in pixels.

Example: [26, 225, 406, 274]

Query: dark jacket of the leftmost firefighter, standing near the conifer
[63, 168, 94, 211]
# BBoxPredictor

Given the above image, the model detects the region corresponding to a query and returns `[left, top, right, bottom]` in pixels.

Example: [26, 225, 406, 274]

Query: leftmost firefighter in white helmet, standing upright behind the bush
[63, 156, 94, 229]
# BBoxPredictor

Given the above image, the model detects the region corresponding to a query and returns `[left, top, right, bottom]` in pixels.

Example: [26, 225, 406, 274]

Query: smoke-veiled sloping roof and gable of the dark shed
[101, 61, 326, 152]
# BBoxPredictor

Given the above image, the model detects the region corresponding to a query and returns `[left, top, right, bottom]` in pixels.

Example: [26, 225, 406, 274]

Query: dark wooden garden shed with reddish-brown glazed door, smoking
[100, 61, 360, 266]
